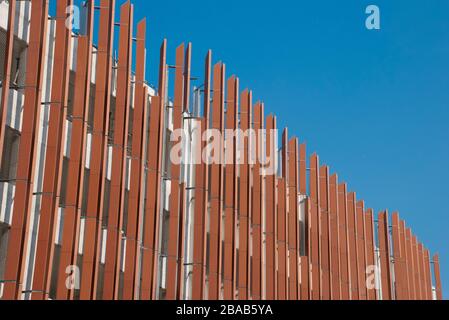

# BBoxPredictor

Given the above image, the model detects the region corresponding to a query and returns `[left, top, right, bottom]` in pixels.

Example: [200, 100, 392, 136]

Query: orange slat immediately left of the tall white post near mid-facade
[165, 44, 184, 300]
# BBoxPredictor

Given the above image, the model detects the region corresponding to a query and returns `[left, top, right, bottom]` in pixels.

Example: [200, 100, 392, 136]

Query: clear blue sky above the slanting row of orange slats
[71, 0, 449, 298]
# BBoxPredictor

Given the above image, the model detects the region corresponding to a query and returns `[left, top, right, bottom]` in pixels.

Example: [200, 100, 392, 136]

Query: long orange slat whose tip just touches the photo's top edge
[103, 2, 133, 299]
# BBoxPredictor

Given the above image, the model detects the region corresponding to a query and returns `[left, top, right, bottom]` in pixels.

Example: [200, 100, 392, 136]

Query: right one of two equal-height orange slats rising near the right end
[391, 212, 405, 300]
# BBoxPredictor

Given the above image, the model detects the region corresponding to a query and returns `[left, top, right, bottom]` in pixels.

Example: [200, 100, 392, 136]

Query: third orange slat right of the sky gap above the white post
[223, 76, 239, 300]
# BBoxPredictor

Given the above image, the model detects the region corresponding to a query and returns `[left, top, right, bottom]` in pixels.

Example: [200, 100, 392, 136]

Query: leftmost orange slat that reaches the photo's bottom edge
[2, 0, 48, 300]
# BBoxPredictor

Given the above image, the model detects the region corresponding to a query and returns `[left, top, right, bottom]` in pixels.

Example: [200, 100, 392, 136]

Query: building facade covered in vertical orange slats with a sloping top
[0, 0, 442, 300]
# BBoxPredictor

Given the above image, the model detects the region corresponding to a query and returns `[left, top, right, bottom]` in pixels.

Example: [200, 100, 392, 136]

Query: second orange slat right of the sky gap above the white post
[209, 63, 225, 300]
